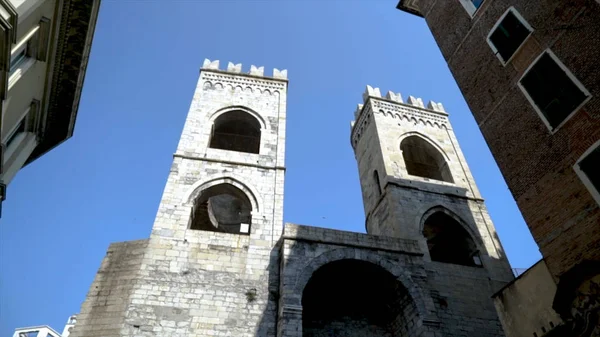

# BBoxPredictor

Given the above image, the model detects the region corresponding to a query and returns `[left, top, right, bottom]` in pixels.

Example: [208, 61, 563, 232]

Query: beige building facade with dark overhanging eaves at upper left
[0, 0, 100, 215]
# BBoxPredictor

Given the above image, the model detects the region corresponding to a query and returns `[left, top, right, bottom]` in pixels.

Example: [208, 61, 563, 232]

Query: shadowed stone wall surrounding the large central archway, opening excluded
[279, 224, 504, 337]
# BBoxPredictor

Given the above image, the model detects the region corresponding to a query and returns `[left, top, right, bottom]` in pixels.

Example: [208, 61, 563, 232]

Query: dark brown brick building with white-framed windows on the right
[397, 0, 600, 336]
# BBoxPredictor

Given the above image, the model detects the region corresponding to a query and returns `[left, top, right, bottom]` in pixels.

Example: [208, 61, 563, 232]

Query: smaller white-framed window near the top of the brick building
[488, 7, 533, 64]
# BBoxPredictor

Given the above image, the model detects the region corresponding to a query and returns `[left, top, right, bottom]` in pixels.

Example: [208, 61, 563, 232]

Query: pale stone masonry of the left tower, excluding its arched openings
[120, 63, 287, 336]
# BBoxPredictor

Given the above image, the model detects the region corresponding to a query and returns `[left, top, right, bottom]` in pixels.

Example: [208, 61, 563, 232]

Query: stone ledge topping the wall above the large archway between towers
[283, 223, 423, 256]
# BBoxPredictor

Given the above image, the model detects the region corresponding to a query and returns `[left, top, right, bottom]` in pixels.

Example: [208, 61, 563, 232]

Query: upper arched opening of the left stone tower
[209, 110, 260, 153]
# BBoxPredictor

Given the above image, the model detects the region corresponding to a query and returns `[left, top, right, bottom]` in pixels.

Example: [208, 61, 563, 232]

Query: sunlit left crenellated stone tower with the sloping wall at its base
[71, 60, 287, 337]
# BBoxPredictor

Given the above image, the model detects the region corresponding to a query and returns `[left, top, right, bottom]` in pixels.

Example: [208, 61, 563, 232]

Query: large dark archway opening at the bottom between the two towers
[302, 260, 418, 337]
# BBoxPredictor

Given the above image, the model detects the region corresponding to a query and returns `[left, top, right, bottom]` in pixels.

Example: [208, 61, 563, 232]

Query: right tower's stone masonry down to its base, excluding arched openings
[352, 87, 514, 336]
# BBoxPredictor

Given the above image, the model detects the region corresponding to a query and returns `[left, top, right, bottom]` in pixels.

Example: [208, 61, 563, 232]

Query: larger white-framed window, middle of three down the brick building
[519, 50, 591, 131]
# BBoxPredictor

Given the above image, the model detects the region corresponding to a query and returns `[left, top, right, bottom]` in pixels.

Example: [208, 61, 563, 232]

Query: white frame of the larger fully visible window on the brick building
[517, 48, 592, 134]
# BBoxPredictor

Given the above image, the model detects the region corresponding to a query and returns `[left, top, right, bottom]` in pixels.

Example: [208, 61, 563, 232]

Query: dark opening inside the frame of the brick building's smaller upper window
[490, 10, 530, 62]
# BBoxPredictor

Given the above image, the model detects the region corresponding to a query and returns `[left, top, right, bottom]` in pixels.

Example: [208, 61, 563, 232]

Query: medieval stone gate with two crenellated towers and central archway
[71, 60, 513, 337]
